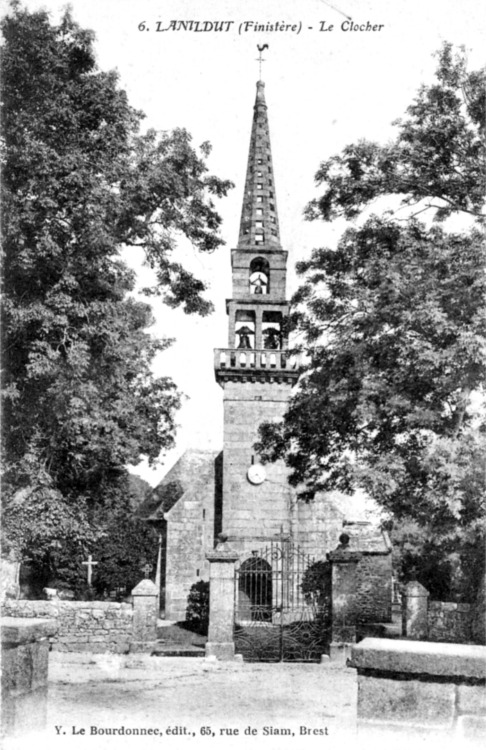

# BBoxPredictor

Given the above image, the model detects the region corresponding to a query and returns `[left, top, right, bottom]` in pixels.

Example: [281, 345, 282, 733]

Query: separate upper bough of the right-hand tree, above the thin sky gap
[307, 43, 486, 221]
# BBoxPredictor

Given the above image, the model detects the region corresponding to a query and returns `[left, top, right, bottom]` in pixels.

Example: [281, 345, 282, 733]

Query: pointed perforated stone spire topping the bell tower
[238, 81, 281, 250]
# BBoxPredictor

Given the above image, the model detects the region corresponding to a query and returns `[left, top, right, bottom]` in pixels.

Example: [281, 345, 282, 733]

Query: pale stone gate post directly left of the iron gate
[206, 534, 238, 661]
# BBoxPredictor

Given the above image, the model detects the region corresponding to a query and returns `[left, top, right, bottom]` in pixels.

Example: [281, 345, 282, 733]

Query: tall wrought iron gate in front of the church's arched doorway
[234, 542, 328, 661]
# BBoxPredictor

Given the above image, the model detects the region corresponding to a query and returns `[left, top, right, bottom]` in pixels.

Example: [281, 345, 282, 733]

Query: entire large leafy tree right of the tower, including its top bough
[257, 45, 486, 598]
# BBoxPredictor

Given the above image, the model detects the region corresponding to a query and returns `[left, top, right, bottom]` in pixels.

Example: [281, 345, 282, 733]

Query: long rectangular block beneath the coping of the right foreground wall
[358, 674, 455, 728]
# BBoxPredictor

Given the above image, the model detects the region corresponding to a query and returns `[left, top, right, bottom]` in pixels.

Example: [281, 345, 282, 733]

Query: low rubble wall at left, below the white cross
[2, 599, 133, 654]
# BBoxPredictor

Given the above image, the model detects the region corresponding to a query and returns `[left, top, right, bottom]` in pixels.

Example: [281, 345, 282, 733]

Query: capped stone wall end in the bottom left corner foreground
[1, 617, 57, 735]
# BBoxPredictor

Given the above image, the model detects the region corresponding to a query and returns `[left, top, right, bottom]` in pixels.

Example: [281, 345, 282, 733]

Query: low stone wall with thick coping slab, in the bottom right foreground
[349, 638, 486, 739]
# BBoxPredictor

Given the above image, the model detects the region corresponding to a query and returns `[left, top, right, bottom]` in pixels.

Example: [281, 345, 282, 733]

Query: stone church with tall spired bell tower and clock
[143, 80, 391, 621]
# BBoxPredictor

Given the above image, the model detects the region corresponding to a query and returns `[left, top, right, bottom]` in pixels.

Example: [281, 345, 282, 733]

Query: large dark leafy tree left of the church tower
[2, 3, 230, 576]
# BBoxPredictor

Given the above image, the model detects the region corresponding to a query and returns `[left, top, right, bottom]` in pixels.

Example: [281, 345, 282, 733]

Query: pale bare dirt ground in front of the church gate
[6, 653, 356, 750]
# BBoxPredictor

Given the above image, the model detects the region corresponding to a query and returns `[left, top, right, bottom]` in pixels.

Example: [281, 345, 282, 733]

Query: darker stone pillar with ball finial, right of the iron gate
[327, 534, 361, 660]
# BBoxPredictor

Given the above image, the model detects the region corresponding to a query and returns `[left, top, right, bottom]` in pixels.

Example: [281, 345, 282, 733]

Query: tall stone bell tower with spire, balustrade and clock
[215, 81, 298, 553]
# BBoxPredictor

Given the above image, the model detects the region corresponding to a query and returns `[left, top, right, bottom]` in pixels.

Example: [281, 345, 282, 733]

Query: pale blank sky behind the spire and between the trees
[8, 0, 486, 486]
